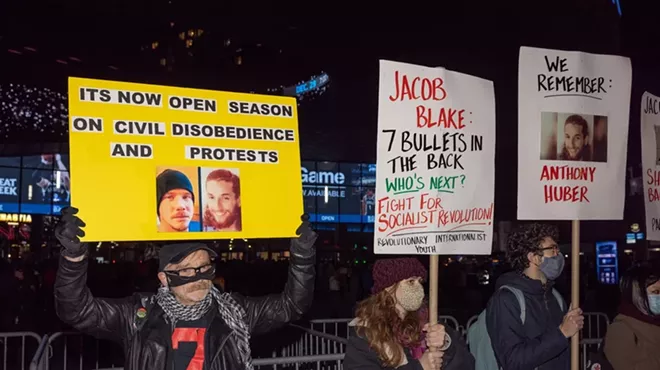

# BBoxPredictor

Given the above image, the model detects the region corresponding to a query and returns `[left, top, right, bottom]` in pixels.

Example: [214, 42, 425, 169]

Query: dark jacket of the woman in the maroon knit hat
[344, 326, 474, 370]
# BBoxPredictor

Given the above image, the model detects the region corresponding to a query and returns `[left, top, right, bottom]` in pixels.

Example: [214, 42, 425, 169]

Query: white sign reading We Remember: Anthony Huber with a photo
[518, 47, 632, 220]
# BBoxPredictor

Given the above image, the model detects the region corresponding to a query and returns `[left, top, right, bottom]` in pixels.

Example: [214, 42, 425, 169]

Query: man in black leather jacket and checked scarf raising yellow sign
[55, 208, 317, 370]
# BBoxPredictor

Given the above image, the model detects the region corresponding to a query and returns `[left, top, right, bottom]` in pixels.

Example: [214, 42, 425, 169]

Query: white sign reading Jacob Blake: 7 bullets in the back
[374, 61, 495, 254]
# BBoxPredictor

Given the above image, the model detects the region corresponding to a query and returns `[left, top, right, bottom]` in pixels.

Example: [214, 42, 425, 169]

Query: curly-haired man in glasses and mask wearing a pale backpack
[468, 223, 584, 370]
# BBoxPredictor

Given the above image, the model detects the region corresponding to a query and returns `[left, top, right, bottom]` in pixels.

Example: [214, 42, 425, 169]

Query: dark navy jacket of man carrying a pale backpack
[486, 272, 571, 370]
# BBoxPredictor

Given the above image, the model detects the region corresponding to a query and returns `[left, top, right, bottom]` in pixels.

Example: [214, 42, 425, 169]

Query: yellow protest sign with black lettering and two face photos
[69, 78, 303, 241]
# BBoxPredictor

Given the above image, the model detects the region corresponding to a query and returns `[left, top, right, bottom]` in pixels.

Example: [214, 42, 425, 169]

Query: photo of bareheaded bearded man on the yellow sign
[201, 168, 243, 231]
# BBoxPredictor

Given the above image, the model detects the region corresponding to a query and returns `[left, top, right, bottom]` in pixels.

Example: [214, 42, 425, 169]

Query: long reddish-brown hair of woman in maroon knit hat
[356, 284, 423, 368]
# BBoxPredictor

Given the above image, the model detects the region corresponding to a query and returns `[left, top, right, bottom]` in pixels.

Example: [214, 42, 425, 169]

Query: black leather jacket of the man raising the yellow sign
[55, 246, 315, 370]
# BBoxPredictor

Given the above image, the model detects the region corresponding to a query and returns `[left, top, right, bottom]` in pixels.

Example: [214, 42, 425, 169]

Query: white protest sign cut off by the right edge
[640, 92, 660, 240]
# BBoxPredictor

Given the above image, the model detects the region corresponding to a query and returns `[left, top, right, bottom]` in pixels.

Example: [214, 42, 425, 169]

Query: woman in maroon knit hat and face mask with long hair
[344, 258, 474, 370]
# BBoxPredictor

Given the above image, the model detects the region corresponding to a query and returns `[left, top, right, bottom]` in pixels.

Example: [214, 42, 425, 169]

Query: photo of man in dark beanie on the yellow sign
[156, 167, 200, 233]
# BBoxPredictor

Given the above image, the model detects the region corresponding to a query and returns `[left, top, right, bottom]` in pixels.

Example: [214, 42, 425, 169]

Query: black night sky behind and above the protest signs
[0, 0, 660, 243]
